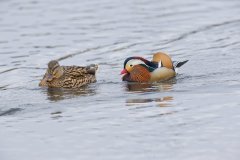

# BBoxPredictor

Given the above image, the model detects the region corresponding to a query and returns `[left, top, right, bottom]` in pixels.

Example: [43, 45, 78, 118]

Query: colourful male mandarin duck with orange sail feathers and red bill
[121, 52, 188, 83]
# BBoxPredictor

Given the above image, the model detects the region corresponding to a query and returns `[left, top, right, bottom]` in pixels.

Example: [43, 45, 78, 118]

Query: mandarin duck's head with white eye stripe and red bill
[121, 57, 148, 74]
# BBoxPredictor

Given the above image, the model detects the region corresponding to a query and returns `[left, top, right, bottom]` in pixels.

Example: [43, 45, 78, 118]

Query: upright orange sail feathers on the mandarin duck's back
[152, 52, 173, 69]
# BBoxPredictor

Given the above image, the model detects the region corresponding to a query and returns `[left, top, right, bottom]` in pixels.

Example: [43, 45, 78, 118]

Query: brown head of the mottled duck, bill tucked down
[45, 60, 63, 82]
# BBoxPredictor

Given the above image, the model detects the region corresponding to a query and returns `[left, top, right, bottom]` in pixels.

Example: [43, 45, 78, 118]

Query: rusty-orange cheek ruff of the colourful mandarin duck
[129, 65, 151, 82]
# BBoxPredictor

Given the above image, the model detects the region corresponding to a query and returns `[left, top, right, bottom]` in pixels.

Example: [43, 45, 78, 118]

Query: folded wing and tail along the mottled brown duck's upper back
[63, 64, 98, 77]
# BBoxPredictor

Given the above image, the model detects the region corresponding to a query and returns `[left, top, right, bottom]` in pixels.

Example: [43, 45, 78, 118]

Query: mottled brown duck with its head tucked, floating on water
[39, 60, 98, 88]
